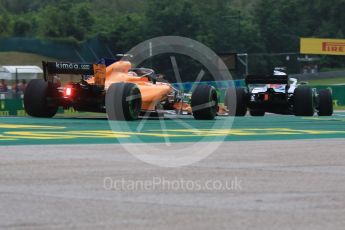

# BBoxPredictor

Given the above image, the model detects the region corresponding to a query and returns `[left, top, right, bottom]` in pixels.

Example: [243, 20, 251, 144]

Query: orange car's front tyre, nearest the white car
[191, 85, 218, 120]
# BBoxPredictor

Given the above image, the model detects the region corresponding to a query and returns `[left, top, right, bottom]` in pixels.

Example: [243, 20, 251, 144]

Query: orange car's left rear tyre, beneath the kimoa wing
[24, 79, 58, 118]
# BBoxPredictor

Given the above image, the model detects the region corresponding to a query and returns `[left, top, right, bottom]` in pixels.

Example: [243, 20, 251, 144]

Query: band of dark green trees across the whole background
[0, 0, 345, 56]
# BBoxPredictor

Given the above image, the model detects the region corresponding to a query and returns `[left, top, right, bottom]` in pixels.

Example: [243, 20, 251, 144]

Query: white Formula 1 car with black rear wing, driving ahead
[225, 68, 333, 116]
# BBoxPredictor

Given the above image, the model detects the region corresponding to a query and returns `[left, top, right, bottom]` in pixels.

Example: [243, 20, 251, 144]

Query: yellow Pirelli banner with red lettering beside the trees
[301, 38, 345, 55]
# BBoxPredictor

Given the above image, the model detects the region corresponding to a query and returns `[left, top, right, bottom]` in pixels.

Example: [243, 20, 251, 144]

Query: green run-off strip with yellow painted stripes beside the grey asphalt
[0, 113, 345, 145]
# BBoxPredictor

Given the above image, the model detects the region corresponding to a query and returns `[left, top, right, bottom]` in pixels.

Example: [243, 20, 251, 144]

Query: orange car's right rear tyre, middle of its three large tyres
[105, 82, 141, 121]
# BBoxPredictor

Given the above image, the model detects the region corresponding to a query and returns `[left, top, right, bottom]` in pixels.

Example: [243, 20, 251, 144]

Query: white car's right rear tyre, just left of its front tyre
[293, 86, 315, 116]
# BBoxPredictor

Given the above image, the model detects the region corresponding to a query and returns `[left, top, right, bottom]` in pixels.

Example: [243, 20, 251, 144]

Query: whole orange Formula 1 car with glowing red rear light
[24, 60, 219, 120]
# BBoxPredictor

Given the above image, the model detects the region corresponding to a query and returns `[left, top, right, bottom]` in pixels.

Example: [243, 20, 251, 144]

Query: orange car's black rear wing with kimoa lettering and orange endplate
[42, 61, 106, 85]
